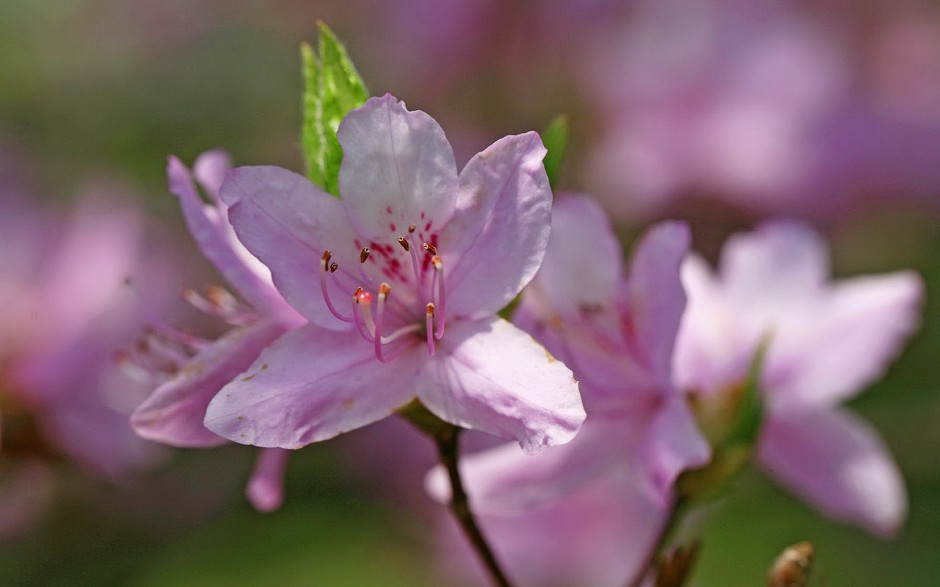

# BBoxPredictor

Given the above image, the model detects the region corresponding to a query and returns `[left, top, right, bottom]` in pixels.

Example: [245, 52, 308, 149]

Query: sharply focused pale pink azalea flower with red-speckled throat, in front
[205, 95, 584, 452]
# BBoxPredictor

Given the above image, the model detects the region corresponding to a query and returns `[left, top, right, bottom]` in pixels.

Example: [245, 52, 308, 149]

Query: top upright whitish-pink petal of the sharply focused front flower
[337, 94, 457, 241]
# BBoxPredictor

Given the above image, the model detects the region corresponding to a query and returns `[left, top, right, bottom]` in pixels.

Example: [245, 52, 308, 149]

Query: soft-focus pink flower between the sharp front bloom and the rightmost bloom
[429, 197, 710, 585]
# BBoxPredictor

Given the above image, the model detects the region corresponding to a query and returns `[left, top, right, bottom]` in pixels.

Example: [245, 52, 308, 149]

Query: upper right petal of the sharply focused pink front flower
[440, 132, 552, 319]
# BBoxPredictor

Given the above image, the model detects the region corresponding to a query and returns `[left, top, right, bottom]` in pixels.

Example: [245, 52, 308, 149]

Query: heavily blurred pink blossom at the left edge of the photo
[0, 185, 175, 479]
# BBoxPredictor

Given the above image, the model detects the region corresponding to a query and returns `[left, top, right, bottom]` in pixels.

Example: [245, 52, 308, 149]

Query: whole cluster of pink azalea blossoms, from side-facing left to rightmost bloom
[121, 90, 923, 585]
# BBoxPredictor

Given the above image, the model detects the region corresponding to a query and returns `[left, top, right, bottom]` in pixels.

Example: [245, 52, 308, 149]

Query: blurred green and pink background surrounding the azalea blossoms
[0, 0, 940, 587]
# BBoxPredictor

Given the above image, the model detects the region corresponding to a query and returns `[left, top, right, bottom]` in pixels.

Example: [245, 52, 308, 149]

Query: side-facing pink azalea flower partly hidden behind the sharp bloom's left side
[130, 151, 304, 511]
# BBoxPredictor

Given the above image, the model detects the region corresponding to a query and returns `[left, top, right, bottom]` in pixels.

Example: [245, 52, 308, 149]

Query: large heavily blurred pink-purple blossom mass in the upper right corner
[586, 0, 940, 216]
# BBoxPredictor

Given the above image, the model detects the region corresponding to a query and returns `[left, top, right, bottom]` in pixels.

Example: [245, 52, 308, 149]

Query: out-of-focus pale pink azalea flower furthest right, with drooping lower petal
[675, 222, 923, 534]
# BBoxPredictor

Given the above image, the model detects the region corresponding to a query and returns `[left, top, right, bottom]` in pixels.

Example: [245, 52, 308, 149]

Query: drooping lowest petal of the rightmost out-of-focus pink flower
[758, 409, 907, 535]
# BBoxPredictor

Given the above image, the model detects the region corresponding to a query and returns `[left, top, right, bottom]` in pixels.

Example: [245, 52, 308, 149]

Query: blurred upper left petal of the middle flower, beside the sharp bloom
[533, 196, 623, 318]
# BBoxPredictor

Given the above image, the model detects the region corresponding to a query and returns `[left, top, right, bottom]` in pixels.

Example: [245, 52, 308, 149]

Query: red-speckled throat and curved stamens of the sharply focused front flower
[320, 222, 446, 362]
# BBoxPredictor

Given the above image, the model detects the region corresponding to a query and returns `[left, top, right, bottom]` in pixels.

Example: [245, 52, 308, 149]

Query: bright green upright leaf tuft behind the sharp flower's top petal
[300, 22, 369, 196]
